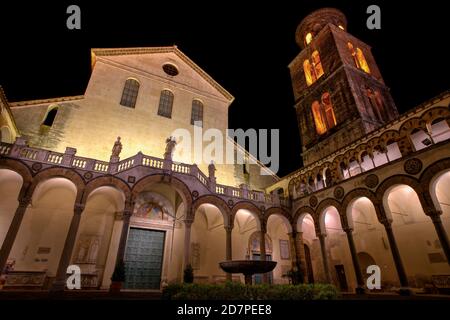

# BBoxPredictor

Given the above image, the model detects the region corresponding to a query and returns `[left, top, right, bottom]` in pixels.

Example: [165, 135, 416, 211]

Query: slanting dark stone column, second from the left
[50, 203, 84, 292]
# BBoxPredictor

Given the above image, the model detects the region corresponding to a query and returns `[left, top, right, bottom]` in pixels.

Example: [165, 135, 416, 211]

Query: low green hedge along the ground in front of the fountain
[163, 282, 338, 300]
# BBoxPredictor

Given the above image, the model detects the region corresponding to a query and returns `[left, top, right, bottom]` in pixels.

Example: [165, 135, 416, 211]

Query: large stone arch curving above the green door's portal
[131, 174, 193, 218]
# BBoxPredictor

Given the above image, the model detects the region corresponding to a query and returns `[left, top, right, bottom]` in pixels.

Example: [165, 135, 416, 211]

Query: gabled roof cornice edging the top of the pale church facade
[91, 45, 234, 104]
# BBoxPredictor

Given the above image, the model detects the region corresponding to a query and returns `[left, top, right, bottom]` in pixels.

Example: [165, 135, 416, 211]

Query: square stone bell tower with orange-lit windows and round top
[289, 8, 398, 165]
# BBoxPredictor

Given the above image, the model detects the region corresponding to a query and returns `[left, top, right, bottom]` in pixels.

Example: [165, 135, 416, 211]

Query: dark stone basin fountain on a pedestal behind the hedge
[219, 260, 277, 284]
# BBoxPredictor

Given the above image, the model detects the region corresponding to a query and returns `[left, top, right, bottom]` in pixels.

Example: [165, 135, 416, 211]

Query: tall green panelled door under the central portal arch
[125, 228, 165, 289]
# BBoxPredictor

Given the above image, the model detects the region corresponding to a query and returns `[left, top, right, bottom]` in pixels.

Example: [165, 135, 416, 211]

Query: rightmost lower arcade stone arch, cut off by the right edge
[419, 158, 450, 212]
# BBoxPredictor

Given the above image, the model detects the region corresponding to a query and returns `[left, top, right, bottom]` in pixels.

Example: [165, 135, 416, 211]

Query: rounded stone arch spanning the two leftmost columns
[27, 167, 85, 203]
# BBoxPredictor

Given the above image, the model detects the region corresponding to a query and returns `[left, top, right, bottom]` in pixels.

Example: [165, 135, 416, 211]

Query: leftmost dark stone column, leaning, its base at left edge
[0, 197, 31, 274]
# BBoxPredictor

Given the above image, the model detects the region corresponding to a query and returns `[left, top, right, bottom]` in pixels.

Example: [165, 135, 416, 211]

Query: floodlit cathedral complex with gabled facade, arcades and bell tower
[0, 8, 450, 292]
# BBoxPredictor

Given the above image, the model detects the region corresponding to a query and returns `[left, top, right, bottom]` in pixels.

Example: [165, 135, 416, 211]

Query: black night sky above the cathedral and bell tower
[0, 0, 450, 176]
